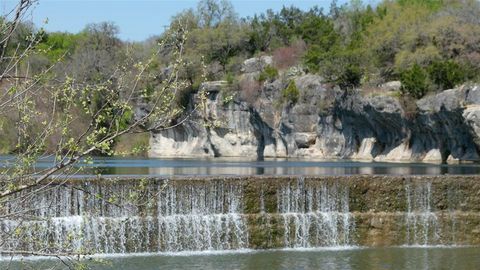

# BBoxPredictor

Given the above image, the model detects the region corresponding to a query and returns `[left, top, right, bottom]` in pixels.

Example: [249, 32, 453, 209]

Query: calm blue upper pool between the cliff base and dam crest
[0, 156, 480, 176]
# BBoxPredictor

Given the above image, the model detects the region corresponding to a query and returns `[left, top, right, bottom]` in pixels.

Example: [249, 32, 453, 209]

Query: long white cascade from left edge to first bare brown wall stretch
[0, 182, 248, 253]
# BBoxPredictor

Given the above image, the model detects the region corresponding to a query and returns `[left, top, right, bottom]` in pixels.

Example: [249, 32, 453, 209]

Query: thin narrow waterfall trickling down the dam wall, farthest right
[405, 182, 441, 245]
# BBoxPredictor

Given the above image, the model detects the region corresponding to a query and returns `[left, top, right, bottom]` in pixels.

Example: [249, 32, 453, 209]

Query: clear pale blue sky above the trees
[0, 0, 374, 41]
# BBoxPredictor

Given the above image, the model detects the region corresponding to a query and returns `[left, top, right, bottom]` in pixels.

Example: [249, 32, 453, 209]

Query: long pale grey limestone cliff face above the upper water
[150, 59, 480, 162]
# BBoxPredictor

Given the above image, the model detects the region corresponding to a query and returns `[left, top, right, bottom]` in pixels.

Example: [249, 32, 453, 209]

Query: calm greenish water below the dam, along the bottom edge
[5, 247, 480, 270]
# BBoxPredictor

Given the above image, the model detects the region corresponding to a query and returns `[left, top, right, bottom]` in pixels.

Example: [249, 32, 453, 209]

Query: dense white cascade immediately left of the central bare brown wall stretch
[158, 186, 248, 251]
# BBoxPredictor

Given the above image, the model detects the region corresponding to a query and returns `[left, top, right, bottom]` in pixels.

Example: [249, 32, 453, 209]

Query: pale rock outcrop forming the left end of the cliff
[150, 79, 269, 157]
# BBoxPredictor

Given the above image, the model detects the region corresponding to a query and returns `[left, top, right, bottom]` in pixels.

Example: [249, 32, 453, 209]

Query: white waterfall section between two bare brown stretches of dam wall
[277, 178, 354, 248]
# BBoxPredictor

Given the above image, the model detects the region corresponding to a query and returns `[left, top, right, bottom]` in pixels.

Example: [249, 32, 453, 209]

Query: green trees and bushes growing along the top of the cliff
[162, 0, 480, 97]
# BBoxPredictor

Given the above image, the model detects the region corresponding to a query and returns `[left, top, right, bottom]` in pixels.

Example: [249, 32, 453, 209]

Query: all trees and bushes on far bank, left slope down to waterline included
[0, 0, 480, 154]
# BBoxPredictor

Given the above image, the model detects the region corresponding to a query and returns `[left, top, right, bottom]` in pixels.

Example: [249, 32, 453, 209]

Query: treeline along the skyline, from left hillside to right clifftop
[4, 0, 480, 98]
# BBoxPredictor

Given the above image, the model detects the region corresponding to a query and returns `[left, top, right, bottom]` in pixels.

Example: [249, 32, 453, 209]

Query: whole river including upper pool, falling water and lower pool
[0, 156, 480, 270]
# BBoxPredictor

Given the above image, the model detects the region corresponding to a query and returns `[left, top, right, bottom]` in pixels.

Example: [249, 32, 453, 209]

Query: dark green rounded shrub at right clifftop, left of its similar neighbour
[400, 64, 430, 99]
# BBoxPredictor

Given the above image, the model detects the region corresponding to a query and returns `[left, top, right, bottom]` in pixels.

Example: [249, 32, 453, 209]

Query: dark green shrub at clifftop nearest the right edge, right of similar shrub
[428, 60, 466, 90]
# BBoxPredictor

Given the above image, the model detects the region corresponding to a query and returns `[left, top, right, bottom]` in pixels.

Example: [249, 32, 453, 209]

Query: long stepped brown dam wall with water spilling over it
[0, 175, 480, 254]
